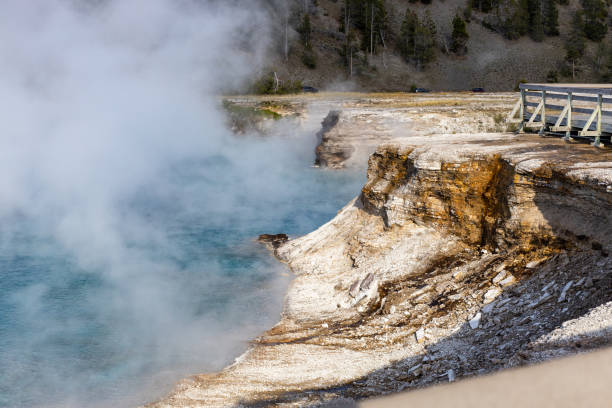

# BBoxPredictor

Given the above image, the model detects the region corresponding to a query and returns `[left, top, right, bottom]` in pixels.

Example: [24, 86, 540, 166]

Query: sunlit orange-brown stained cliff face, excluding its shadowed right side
[362, 146, 512, 246]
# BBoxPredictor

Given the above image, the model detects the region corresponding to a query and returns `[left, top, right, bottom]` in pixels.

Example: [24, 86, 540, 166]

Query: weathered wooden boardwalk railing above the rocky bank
[508, 84, 612, 146]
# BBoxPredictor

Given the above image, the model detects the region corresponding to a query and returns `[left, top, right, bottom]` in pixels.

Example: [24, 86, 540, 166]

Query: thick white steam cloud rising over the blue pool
[0, 0, 340, 406]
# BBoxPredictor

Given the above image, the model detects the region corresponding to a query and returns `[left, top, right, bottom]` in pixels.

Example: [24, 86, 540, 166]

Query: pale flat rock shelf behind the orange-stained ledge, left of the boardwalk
[315, 93, 516, 169]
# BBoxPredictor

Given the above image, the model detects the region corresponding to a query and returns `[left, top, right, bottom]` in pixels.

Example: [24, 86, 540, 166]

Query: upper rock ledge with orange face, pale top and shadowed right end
[361, 142, 612, 251]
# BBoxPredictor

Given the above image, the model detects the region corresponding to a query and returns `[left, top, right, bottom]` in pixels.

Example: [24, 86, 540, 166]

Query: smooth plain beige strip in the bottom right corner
[359, 348, 612, 408]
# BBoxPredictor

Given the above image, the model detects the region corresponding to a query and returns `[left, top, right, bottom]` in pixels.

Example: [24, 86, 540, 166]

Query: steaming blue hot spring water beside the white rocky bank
[0, 133, 364, 407]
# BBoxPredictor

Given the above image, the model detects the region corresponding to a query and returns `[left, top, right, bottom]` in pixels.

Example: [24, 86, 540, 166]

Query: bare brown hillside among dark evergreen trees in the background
[267, 0, 612, 91]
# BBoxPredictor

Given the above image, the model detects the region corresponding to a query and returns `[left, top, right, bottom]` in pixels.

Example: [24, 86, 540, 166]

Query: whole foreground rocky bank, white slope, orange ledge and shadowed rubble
[153, 134, 612, 407]
